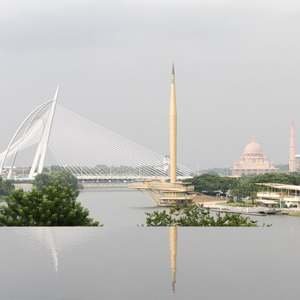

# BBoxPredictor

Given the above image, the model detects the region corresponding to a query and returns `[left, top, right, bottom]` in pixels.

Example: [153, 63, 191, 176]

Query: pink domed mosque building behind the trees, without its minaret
[231, 136, 278, 177]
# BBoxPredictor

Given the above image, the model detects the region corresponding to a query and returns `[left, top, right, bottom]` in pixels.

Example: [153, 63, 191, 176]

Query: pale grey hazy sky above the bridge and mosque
[0, 0, 300, 169]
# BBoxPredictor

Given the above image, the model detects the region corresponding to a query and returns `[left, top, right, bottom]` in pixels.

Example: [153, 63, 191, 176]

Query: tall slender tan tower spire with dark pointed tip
[169, 61, 177, 183]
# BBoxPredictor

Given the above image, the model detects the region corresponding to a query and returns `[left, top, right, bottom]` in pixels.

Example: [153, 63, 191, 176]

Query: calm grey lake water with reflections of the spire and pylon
[0, 191, 300, 300]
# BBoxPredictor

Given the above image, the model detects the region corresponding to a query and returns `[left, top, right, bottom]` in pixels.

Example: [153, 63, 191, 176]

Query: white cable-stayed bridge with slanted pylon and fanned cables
[0, 90, 196, 181]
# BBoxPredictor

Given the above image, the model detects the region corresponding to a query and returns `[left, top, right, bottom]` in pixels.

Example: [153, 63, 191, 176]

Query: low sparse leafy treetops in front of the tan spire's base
[145, 204, 258, 227]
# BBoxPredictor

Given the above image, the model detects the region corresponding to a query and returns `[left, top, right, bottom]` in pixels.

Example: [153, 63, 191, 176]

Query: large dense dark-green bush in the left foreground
[0, 183, 99, 226]
